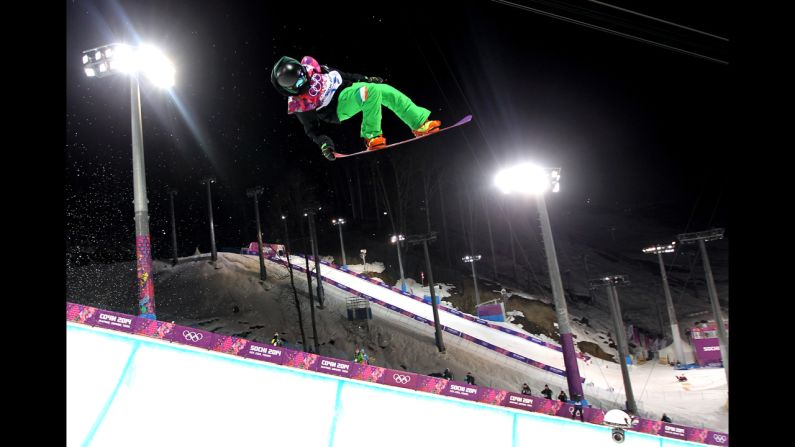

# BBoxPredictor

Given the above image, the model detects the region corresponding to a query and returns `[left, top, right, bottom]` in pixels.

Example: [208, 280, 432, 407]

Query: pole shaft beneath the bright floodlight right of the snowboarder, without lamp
[537, 194, 584, 397]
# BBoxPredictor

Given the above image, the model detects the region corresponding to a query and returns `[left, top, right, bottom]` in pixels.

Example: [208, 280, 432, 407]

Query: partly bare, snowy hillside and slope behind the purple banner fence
[67, 253, 728, 431]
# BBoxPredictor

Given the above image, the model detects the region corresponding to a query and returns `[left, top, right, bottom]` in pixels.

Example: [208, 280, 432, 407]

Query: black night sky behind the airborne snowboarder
[64, 0, 731, 259]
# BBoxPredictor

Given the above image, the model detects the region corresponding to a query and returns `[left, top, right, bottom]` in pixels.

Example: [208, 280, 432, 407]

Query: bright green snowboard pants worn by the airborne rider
[337, 82, 431, 138]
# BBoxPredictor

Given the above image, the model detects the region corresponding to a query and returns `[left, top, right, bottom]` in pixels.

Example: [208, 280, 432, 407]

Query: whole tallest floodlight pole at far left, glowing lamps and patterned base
[82, 44, 175, 320]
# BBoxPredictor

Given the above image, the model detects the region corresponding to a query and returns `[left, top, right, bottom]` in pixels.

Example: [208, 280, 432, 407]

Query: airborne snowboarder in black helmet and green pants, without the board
[271, 56, 441, 160]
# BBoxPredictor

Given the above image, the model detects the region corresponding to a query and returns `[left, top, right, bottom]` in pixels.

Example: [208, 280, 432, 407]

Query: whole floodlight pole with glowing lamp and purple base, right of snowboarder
[494, 163, 585, 397]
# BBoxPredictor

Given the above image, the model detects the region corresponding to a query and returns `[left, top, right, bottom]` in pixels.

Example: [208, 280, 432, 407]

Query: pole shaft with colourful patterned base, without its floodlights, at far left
[130, 75, 156, 320]
